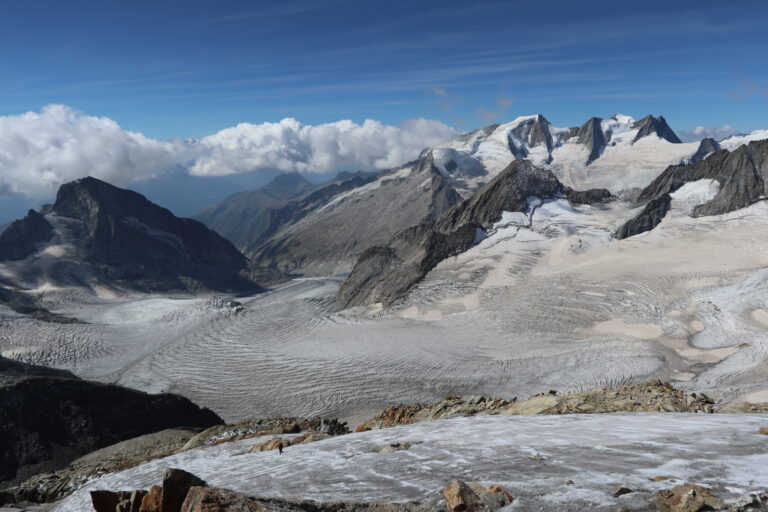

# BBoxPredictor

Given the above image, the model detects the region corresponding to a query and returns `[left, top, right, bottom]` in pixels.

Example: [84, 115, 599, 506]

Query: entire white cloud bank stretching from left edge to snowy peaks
[0, 105, 457, 199]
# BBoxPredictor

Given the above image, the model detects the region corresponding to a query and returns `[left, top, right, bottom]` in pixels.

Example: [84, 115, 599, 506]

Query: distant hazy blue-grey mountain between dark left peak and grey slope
[193, 173, 317, 250]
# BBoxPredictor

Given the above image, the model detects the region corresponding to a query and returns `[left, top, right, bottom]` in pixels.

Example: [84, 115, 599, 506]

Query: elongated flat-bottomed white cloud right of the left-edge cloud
[185, 118, 457, 176]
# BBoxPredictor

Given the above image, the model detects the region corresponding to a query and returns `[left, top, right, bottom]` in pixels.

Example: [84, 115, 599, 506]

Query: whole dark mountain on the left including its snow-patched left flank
[0, 178, 276, 291]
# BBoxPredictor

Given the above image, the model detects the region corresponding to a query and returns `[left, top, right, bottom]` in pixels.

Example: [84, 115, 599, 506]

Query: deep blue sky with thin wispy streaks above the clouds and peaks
[0, 0, 768, 139]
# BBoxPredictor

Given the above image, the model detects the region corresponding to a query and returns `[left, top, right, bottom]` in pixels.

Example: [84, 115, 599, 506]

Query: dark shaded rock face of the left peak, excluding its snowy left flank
[51, 178, 254, 290]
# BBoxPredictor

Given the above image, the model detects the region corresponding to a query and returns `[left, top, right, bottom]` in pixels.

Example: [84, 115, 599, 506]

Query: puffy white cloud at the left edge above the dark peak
[0, 105, 176, 198]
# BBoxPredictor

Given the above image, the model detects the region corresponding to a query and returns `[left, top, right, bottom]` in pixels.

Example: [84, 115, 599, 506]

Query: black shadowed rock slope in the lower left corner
[0, 365, 223, 483]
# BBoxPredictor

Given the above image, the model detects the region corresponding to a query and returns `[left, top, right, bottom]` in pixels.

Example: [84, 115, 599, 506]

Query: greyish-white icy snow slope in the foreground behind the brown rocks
[54, 414, 768, 512]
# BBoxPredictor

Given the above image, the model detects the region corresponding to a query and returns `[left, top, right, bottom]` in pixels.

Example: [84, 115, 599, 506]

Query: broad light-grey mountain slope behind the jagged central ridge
[251, 152, 461, 275]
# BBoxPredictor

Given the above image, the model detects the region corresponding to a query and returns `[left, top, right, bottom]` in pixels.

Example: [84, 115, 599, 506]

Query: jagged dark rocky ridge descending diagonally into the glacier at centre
[335, 160, 612, 310]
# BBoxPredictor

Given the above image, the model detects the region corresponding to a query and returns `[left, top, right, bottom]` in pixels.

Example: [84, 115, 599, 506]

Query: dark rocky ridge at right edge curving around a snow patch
[616, 140, 768, 238]
